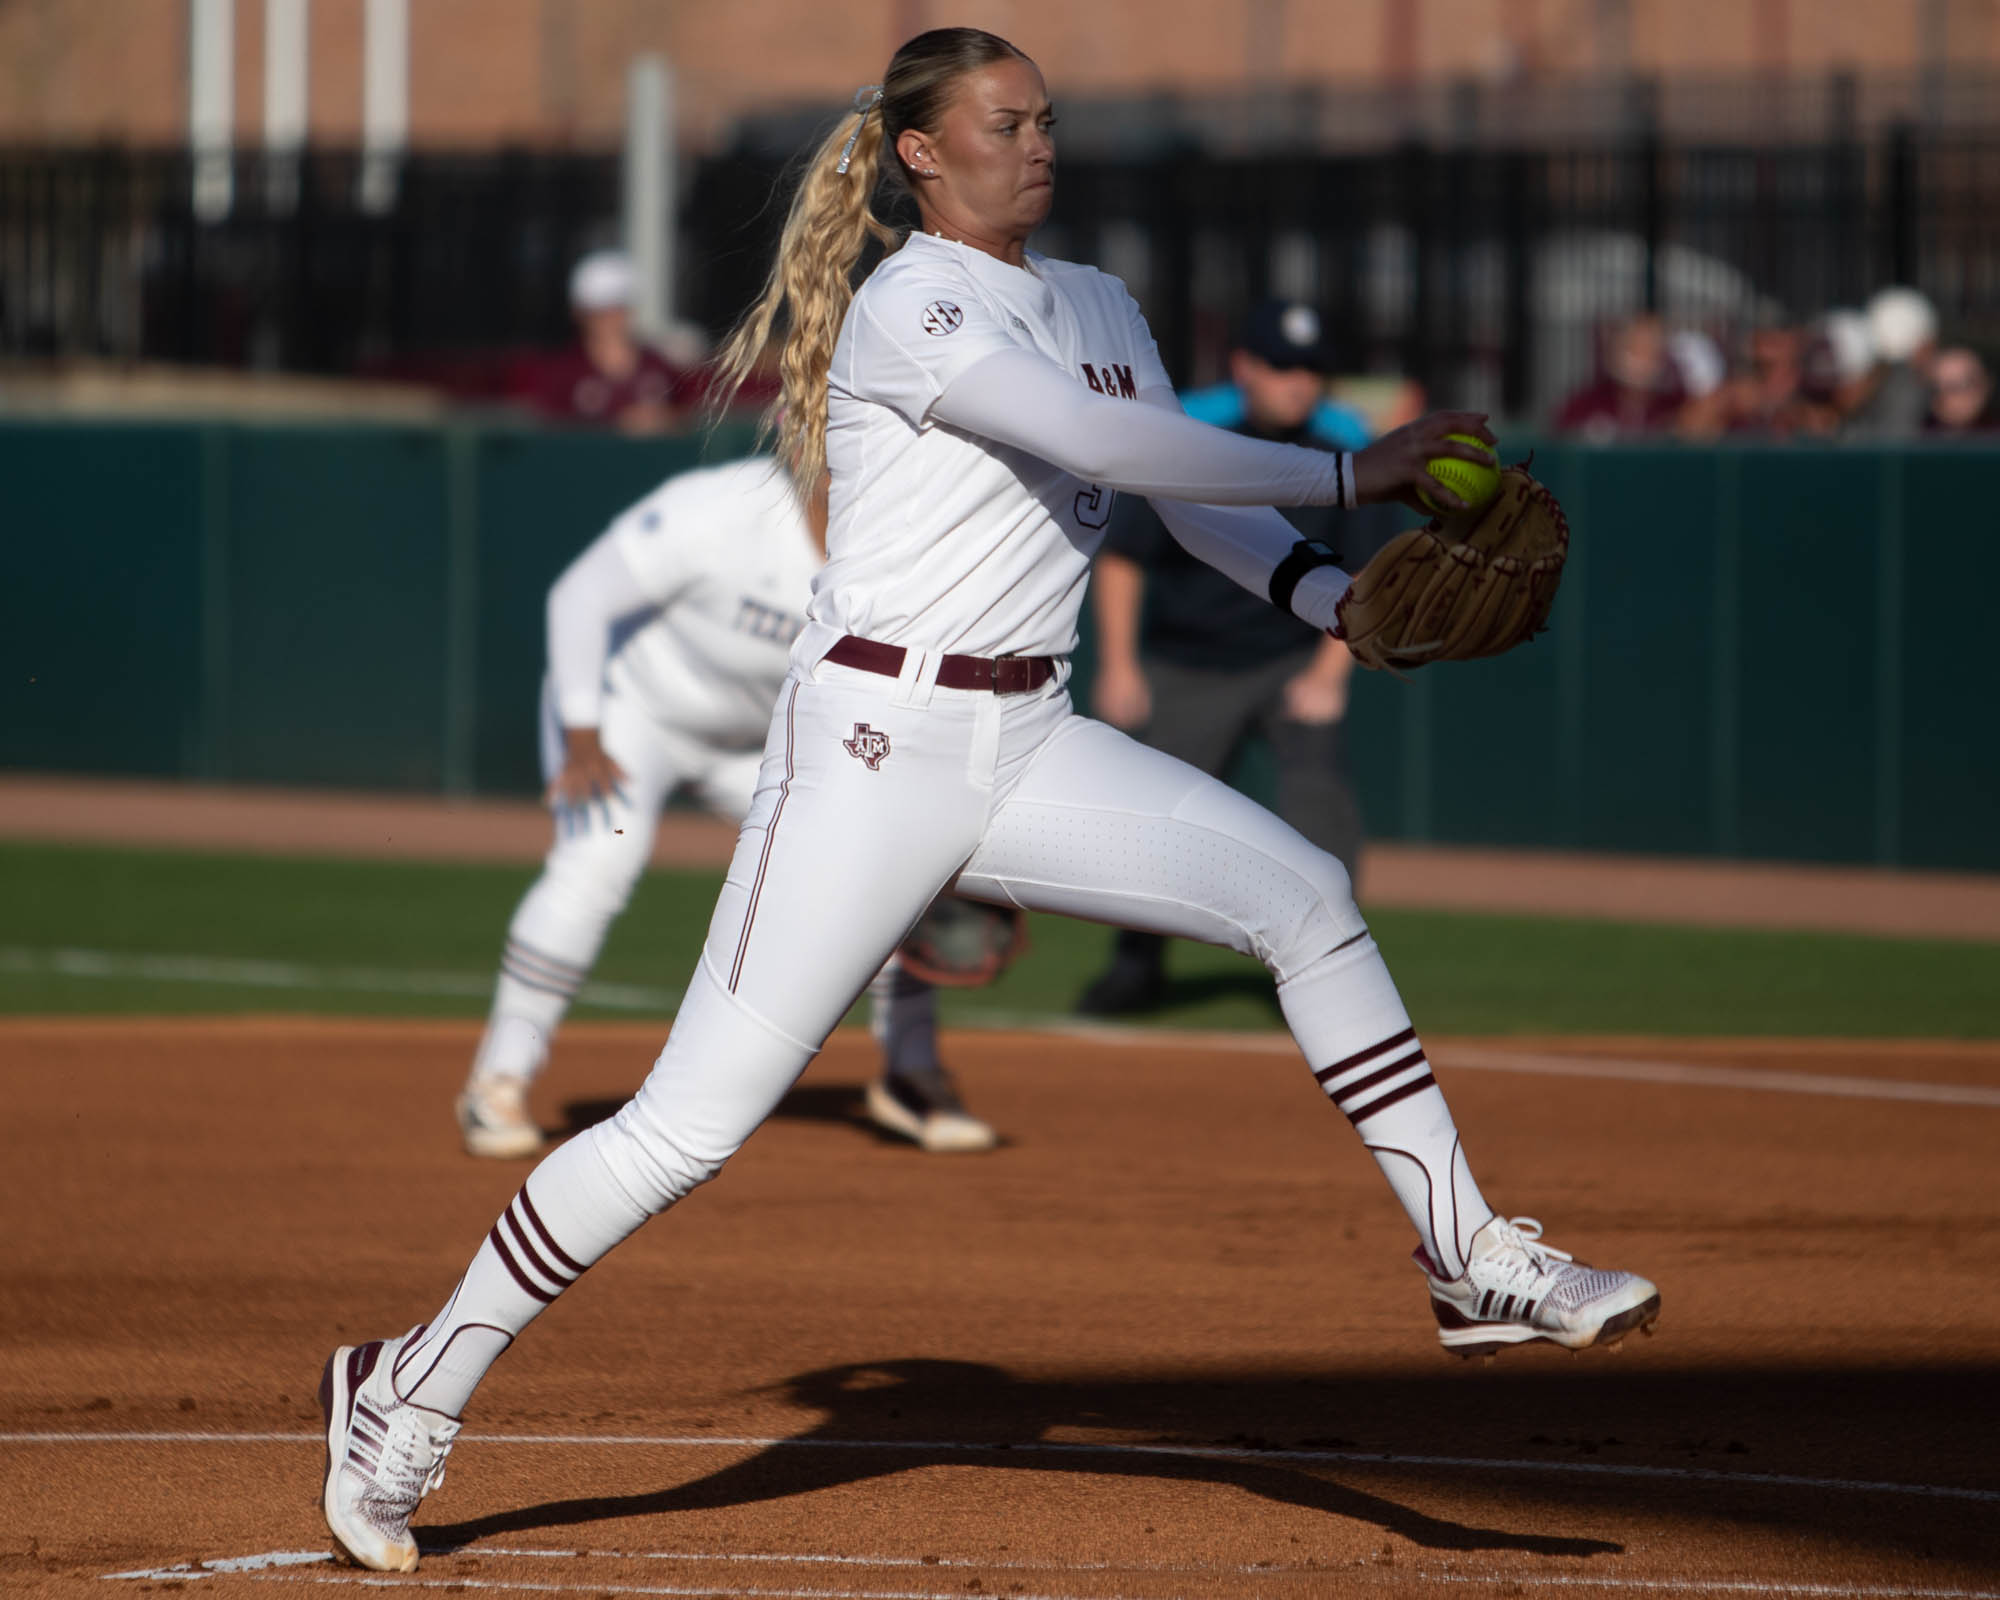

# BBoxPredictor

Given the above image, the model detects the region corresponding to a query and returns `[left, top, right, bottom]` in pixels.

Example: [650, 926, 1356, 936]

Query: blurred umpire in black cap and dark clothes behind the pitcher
[1076, 300, 1402, 1016]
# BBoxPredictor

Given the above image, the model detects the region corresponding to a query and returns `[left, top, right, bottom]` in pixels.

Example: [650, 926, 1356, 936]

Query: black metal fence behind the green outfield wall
[0, 124, 2000, 414]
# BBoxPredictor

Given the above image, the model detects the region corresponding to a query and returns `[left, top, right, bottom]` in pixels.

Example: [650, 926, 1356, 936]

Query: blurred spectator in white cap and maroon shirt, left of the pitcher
[510, 250, 688, 434]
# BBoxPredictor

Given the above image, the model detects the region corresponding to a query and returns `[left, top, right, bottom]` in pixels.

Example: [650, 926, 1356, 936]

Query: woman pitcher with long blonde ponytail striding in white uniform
[322, 28, 1660, 1570]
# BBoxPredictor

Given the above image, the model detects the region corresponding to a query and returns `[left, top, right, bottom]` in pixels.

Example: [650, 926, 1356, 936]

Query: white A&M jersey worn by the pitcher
[802, 234, 1352, 660]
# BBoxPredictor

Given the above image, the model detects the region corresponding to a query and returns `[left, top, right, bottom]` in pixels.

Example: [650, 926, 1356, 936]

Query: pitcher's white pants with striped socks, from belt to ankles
[396, 652, 1492, 1416]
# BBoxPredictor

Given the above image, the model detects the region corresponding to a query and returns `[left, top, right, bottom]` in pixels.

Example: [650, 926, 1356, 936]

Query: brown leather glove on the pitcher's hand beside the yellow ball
[1334, 466, 1570, 672]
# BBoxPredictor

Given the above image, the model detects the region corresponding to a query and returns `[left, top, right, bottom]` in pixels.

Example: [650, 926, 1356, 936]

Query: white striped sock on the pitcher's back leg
[392, 1130, 650, 1416]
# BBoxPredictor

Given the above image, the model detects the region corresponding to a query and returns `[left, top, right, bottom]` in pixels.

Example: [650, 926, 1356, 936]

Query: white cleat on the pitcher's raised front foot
[1416, 1216, 1660, 1358]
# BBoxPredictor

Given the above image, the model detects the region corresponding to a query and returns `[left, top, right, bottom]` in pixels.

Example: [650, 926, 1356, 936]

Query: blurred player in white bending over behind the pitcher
[456, 456, 996, 1158]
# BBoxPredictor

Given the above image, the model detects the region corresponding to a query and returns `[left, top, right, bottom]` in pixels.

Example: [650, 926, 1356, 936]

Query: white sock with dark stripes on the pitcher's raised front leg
[1278, 934, 1494, 1278]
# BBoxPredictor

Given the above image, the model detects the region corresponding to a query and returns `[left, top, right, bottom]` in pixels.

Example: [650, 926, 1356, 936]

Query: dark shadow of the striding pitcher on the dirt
[418, 1358, 1624, 1556]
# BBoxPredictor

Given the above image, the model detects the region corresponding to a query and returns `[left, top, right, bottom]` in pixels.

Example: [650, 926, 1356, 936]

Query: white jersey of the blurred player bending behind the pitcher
[576, 456, 820, 750]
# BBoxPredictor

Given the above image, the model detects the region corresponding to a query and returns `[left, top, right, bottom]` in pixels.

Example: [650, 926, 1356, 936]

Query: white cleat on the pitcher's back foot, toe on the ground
[320, 1328, 458, 1572]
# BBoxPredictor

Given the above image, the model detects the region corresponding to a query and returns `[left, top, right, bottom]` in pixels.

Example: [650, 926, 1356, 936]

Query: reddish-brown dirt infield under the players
[0, 1020, 2000, 1600]
